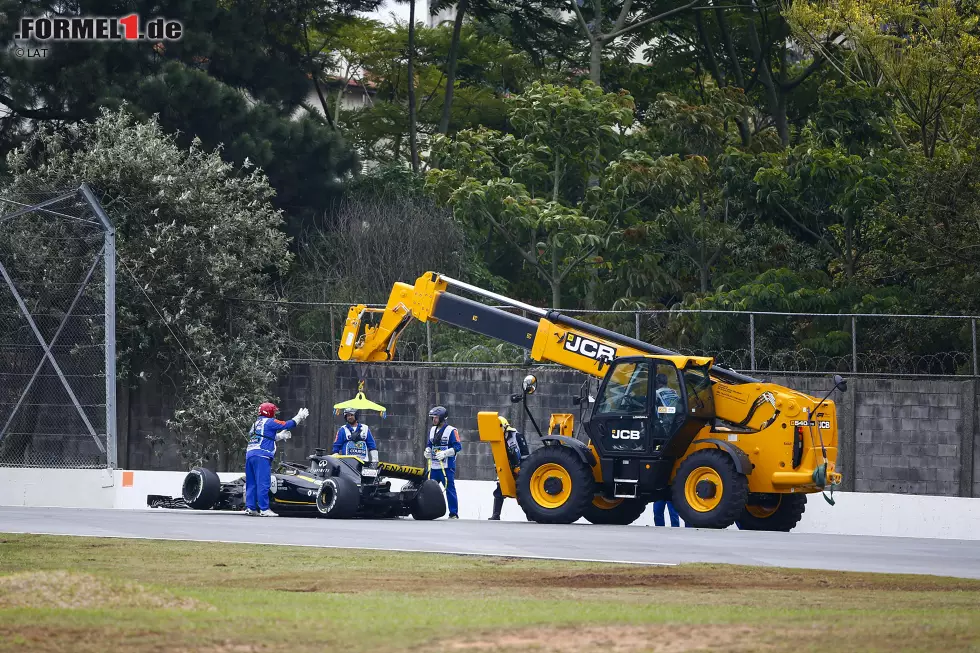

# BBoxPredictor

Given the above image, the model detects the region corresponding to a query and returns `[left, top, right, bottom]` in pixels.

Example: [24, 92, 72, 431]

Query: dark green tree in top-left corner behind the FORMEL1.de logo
[0, 0, 377, 233]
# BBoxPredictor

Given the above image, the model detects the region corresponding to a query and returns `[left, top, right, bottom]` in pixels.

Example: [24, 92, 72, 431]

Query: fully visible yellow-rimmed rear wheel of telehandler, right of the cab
[671, 449, 749, 528]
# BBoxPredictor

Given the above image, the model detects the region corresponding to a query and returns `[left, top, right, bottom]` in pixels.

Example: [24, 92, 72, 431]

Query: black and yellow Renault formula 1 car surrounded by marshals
[147, 449, 446, 520]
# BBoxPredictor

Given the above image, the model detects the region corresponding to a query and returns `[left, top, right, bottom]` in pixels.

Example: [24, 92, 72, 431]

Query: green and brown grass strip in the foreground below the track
[0, 534, 980, 653]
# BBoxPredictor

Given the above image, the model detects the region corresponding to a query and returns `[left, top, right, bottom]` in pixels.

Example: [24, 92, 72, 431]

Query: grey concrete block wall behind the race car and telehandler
[119, 363, 980, 497]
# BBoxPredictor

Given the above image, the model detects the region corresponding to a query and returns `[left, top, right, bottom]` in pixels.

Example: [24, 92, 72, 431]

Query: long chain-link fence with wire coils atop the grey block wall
[255, 302, 980, 376]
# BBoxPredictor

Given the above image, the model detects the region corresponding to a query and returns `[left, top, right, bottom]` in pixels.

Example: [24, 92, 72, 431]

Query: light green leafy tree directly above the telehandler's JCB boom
[428, 82, 704, 308]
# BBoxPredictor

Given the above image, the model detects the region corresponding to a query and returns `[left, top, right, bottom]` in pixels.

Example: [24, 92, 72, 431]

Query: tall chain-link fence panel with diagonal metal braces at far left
[0, 185, 116, 468]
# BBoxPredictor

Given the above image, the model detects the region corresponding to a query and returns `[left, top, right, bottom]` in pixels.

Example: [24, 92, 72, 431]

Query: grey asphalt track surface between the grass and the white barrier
[0, 506, 980, 579]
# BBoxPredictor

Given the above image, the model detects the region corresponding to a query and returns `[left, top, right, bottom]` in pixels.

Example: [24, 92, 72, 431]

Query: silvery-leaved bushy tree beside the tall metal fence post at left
[7, 108, 292, 464]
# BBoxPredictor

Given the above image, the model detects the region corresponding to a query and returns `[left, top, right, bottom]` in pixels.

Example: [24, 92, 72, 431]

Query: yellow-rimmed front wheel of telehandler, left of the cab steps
[517, 445, 595, 524]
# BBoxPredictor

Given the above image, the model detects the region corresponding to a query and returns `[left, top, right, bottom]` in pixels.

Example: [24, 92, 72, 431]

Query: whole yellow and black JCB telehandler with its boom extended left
[339, 272, 847, 531]
